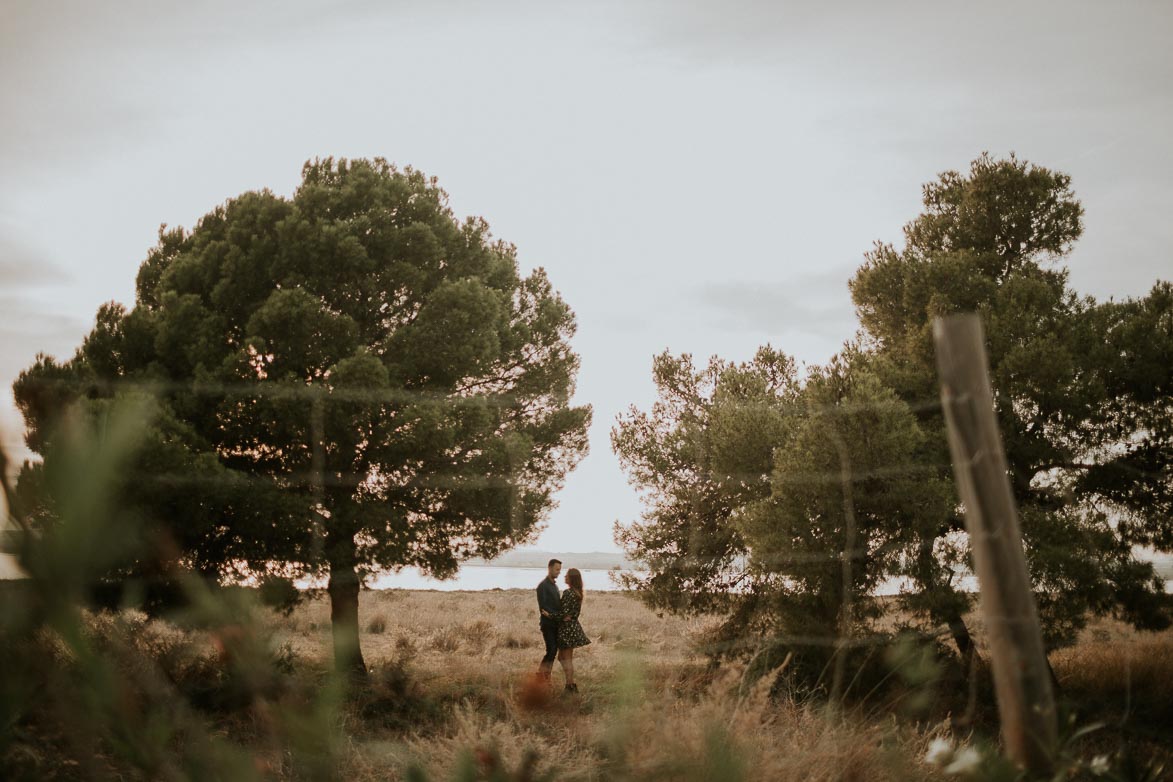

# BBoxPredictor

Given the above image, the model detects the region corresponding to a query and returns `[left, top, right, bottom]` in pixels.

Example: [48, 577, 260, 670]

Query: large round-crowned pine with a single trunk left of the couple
[14, 158, 590, 673]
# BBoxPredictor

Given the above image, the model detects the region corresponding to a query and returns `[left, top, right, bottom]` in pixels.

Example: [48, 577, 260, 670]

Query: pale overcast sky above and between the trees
[0, 0, 1173, 551]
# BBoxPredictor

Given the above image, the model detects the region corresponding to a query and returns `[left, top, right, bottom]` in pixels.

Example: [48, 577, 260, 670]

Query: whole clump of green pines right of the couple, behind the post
[612, 150, 1173, 685]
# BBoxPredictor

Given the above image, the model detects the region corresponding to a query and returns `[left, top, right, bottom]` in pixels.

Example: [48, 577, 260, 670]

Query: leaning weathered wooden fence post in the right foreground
[933, 314, 1058, 774]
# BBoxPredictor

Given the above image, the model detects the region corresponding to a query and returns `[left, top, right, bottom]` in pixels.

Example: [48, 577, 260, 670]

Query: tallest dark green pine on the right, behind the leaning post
[850, 156, 1173, 647]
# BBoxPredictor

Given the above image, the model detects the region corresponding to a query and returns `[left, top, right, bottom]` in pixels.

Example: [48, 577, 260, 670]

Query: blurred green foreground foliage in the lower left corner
[0, 399, 343, 780]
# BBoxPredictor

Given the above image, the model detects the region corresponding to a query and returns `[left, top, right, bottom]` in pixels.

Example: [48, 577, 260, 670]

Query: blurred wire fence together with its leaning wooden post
[0, 316, 1168, 769]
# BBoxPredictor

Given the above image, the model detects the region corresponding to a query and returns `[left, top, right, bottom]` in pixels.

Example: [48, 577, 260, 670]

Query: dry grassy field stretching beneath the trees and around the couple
[0, 581, 1173, 782]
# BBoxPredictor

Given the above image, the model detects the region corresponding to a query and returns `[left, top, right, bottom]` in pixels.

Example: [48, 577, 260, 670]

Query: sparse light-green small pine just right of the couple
[611, 348, 795, 627]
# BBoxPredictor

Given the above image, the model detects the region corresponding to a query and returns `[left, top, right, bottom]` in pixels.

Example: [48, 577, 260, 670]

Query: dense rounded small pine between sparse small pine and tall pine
[738, 356, 949, 669]
